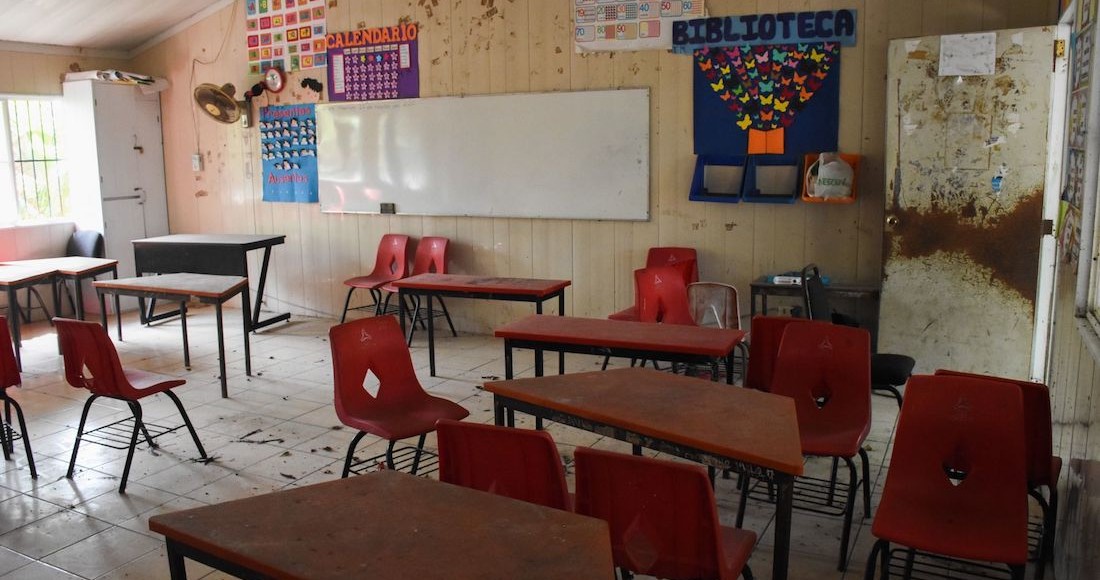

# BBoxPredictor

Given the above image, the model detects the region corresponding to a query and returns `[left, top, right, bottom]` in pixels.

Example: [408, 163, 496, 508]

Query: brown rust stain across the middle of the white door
[888, 191, 1043, 306]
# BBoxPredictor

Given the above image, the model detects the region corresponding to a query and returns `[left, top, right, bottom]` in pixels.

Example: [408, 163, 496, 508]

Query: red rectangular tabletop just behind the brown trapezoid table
[494, 315, 745, 357]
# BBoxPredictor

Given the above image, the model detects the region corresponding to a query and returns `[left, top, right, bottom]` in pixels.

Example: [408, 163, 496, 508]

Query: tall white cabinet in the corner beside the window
[63, 80, 168, 307]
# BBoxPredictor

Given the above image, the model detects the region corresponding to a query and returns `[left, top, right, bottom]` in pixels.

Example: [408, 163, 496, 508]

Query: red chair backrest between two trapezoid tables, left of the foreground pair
[436, 419, 572, 510]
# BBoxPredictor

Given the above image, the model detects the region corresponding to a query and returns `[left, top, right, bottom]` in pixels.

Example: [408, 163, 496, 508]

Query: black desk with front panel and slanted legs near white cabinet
[132, 233, 290, 330]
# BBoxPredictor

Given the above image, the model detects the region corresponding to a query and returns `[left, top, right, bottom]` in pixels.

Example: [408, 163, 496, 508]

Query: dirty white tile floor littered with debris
[0, 307, 1053, 580]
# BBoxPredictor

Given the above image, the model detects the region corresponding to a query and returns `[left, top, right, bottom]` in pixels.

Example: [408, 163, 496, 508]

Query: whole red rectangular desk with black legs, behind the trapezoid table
[494, 315, 745, 384]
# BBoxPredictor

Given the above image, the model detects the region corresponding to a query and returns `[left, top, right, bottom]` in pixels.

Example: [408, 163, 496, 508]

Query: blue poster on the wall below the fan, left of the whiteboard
[260, 103, 317, 204]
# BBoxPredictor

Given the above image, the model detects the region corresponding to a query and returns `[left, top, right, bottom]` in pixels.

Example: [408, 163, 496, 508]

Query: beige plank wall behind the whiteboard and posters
[131, 0, 1055, 332]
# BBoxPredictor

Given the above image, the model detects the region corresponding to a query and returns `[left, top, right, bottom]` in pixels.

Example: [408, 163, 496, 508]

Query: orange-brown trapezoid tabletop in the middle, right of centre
[485, 368, 802, 475]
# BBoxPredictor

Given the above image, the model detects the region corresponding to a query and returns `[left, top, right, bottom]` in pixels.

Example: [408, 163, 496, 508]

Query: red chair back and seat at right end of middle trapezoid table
[770, 320, 871, 433]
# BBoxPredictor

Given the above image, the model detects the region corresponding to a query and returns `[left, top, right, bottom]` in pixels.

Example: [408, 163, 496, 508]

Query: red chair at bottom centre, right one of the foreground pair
[574, 447, 757, 580]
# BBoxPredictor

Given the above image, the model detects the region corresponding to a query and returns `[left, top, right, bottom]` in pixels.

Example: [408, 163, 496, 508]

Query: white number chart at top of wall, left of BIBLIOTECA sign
[573, 0, 706, 53]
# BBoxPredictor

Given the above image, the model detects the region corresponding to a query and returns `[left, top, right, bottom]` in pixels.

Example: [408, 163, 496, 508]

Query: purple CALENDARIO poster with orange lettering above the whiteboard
[328, 22, 420, 101]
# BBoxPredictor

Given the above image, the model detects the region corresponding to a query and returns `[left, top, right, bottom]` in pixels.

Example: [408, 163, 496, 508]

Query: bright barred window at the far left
[0, 98, 69, 222]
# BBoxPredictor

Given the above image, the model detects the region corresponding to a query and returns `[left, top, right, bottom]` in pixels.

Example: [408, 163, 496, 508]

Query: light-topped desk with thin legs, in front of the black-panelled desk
[92, 273, 252, 398]
